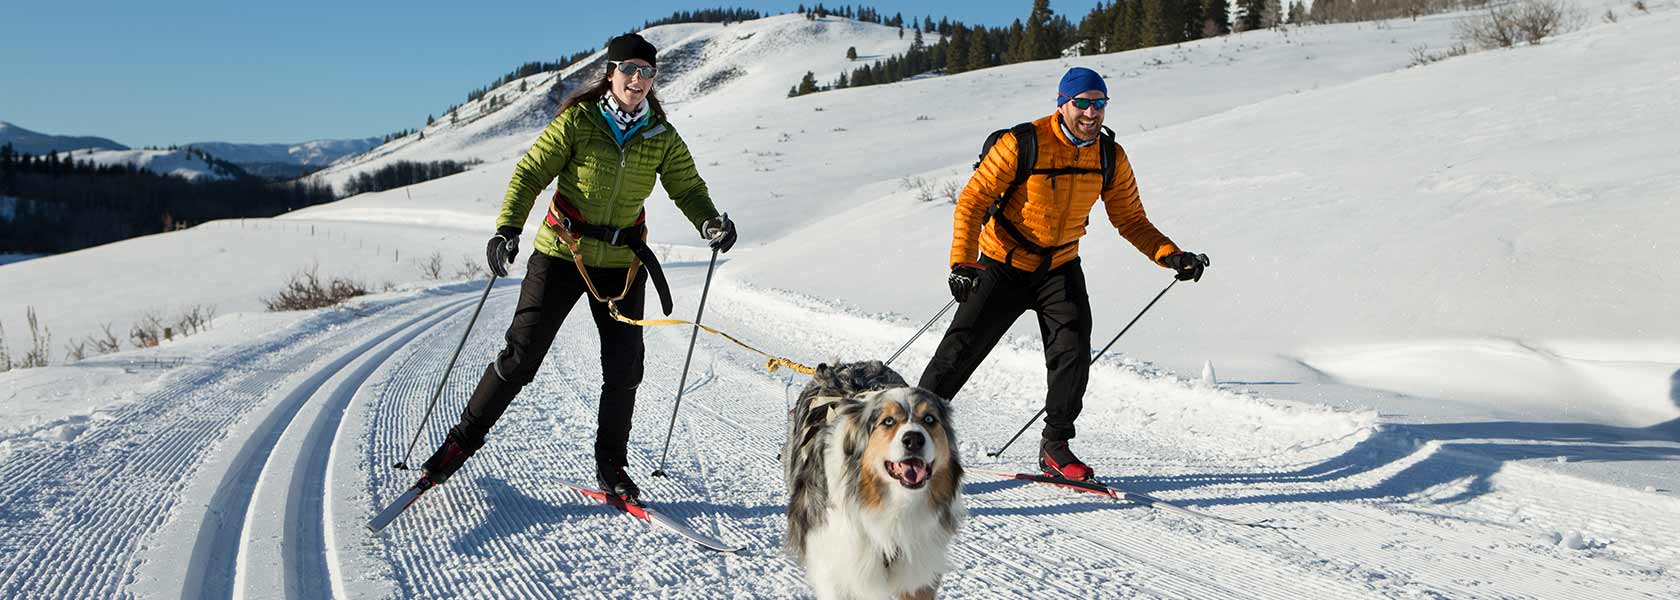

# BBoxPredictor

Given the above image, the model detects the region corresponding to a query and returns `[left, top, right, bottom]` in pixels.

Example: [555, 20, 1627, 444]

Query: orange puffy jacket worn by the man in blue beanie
[951, 114, 1178, 271]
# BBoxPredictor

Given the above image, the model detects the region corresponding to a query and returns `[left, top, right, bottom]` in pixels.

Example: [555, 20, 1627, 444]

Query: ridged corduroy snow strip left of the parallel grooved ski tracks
[0, 282, 480, 598]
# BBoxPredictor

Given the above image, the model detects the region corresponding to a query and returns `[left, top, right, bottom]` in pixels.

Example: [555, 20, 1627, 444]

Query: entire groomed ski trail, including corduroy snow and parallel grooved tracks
[0, 266, 1680, 600]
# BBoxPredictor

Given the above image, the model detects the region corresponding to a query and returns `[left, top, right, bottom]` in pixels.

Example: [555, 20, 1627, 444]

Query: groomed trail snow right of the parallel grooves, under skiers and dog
[320, 267, 1680, 598]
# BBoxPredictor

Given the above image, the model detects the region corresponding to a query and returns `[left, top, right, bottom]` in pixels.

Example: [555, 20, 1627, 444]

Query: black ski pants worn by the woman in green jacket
[450, 252, 647, 466]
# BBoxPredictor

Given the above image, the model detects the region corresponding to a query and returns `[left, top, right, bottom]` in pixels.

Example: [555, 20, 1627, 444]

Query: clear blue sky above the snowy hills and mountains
[0, 0, 1095, 146]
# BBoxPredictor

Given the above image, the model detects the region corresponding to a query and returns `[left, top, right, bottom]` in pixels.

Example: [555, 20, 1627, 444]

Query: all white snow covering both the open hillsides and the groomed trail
[0, 3, 1680, 598]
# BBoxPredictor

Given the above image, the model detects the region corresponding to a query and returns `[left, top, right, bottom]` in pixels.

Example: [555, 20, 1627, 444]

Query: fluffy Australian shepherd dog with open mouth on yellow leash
[781, 361, 968, 600]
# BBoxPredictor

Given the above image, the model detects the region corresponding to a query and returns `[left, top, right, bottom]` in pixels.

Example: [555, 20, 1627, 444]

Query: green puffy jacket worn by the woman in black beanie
[496, 103, 717, 267]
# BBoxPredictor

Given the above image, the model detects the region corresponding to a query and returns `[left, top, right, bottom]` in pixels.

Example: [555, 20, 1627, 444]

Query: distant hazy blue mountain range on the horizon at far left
[0, 121, 381, 180]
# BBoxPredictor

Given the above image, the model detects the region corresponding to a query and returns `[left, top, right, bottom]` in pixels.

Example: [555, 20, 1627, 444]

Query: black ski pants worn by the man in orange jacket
[917, 257, 1090, 440]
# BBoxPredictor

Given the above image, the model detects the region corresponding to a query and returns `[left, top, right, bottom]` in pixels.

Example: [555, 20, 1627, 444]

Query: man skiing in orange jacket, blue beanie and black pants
[917, 67, 1205, 481]
